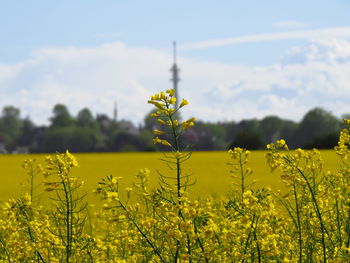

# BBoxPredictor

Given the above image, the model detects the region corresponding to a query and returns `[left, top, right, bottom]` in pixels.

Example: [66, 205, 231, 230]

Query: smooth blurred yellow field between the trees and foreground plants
[0, 150, 340, 202]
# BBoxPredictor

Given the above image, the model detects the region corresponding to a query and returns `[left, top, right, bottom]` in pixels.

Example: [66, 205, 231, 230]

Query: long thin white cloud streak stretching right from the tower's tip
[180, 27, 350, 50]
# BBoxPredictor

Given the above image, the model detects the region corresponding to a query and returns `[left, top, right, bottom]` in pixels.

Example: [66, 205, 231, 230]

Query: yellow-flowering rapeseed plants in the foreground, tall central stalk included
[0, 90, 350, 262]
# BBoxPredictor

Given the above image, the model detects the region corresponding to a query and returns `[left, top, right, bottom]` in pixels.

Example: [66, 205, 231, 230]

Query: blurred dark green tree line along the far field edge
[0, 104, 349, 153]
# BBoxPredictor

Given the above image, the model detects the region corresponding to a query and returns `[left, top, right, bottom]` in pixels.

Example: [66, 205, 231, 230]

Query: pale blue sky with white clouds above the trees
[0, 0, 350, 125]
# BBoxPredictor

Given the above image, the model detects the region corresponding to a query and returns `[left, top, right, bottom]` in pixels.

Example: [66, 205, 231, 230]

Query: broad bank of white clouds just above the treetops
[0, 38, 350, 127]
